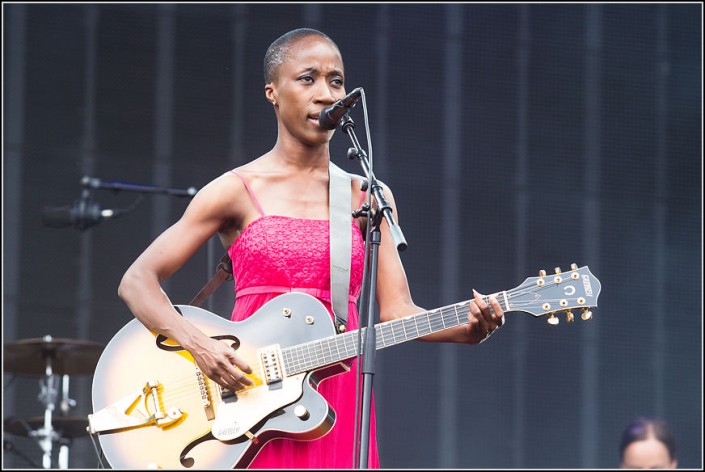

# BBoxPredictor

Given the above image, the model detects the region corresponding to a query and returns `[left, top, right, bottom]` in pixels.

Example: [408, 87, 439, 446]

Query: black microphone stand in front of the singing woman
[341, 113, 407, 469]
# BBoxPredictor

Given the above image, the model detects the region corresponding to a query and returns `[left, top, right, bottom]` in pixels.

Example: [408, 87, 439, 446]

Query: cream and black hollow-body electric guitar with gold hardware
[88, 264, 601, 469]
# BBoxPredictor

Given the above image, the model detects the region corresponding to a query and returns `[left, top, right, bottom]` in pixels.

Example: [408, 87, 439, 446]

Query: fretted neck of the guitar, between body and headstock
[282, 292, 509, 375]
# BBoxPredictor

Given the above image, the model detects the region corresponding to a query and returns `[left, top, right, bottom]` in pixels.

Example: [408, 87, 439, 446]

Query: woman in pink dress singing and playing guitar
[118, 29, 504, 468]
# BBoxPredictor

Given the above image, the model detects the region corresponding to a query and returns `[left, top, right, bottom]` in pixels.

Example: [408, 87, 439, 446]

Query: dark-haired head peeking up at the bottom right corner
[619, 416, 678, 469]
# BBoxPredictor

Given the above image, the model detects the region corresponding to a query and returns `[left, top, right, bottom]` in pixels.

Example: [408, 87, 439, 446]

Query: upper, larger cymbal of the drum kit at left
[3, 336, 104, 375]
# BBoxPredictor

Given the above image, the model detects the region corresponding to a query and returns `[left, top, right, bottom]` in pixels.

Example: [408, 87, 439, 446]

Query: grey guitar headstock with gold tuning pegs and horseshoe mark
[507, 264, 602, 325]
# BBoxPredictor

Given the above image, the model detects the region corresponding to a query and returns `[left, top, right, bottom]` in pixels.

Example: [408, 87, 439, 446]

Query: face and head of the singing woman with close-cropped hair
[265, 36, 345, 145]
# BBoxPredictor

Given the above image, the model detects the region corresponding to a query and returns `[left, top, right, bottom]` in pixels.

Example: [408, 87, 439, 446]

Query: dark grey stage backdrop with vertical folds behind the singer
[3, 3, 703, 469]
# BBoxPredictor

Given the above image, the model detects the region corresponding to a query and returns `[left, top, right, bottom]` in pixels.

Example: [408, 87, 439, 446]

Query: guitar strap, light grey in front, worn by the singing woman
[189, 162, 352, 333]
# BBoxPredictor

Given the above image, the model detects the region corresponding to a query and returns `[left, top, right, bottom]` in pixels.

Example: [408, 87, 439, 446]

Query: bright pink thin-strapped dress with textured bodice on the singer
[228, 171, 379, 469]
